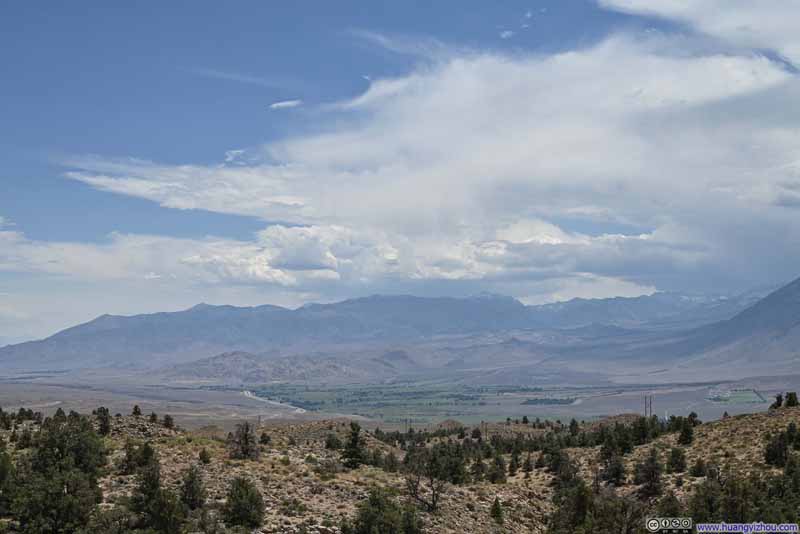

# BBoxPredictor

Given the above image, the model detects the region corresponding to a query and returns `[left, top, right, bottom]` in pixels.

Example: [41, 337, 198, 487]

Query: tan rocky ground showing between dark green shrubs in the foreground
[0, 408, 800, 534]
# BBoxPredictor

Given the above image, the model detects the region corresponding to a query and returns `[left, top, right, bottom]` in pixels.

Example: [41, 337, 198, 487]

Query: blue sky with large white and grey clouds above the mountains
[0, 0, 800, 345]
